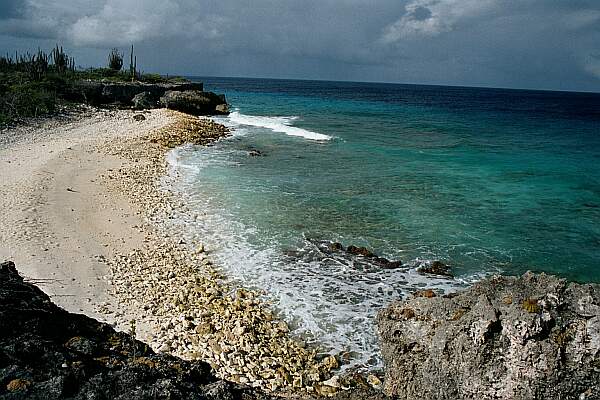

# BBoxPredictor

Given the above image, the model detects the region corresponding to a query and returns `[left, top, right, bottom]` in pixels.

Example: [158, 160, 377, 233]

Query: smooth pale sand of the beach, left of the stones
[0, 110, 172, 320]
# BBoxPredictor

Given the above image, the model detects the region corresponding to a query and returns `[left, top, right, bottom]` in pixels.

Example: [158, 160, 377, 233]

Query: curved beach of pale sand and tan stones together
[0, 110, 356, 394]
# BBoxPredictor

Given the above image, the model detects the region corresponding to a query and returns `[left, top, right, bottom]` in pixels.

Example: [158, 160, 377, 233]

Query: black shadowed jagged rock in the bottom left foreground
[0, 262, 271, 400]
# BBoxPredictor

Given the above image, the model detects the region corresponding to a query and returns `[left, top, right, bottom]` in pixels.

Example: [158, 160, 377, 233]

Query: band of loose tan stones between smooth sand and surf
[92, 113, 381, 395]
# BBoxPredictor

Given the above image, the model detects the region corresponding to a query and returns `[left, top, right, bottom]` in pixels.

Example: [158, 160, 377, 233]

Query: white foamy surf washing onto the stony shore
[164, 143, 477, 371]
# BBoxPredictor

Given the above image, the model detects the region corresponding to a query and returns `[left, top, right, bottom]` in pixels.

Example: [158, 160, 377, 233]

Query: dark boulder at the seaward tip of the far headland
[160, 90, 229, 115]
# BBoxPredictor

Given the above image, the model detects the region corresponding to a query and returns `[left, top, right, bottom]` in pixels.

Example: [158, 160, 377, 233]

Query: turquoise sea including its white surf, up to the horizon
[166, 78, 600, 368]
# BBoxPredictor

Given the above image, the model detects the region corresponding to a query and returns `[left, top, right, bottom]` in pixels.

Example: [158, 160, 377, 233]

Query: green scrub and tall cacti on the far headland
[0, 45, 185, 125]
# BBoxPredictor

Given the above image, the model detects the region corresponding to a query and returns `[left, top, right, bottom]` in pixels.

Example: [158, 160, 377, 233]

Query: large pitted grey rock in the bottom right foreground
[378, 273, 600, 399]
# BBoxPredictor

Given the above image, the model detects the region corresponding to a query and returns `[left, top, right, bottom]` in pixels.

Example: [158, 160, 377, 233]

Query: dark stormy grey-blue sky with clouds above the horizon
[0, 0, 600, 92]
